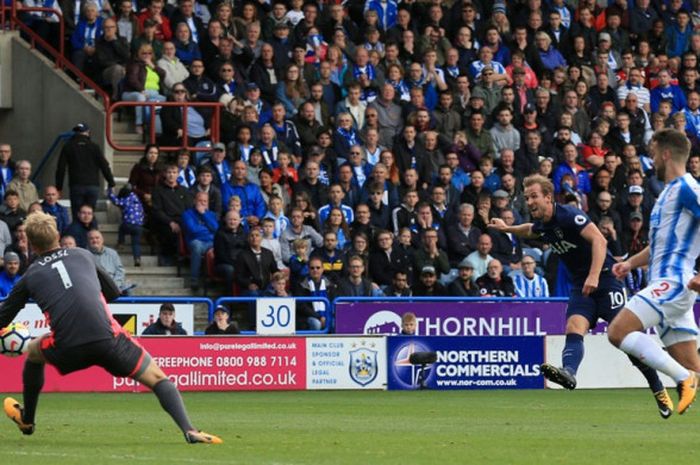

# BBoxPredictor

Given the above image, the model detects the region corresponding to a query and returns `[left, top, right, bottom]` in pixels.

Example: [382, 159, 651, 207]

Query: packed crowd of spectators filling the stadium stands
[8, 0, 700, 328]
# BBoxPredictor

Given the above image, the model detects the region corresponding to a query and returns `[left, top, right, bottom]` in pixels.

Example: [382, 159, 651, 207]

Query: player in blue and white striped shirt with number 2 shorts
[608, 129, 700, 414]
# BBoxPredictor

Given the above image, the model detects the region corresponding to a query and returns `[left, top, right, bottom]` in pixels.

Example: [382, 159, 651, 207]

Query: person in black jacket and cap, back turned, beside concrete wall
[56, 123, 115, 218]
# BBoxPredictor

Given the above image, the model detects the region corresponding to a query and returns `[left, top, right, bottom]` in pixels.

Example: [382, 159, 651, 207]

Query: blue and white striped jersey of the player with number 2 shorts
[649, 173, 700, 284]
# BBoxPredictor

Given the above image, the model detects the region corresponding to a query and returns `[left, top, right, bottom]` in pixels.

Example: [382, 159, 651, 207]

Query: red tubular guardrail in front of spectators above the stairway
[105, 101, 223, 152]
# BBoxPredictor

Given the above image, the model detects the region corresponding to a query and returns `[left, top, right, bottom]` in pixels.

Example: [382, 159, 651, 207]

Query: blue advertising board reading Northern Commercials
[387, 336, 545, 390]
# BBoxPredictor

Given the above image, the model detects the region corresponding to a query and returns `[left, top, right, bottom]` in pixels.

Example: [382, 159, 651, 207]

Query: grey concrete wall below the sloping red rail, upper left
[0, 32, 113, 186]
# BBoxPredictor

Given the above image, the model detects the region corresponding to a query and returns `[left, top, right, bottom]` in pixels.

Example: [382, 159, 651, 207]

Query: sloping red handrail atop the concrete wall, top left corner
[2, 2, 110, 110]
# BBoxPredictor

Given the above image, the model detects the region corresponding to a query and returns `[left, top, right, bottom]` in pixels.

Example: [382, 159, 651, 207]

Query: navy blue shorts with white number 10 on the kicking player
[566, 276, 627, 328]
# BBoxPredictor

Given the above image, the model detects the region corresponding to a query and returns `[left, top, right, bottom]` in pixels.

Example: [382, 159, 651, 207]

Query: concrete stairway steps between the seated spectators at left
[96, 118, 192, 296]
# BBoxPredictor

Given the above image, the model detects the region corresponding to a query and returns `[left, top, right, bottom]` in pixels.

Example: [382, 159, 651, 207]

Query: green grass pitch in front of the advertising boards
[0, 390, 700, 465]
